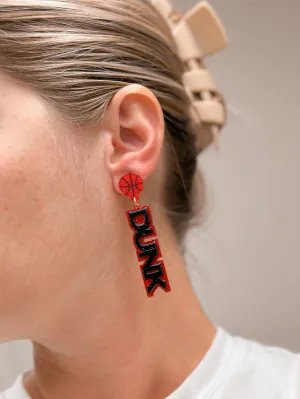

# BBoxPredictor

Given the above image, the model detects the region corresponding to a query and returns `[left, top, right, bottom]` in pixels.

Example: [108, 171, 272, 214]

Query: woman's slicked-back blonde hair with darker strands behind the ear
[0, 0, 205, 241]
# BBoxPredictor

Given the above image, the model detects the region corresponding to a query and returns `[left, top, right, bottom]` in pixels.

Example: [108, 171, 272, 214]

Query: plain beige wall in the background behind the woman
[0, 0, 300, 390]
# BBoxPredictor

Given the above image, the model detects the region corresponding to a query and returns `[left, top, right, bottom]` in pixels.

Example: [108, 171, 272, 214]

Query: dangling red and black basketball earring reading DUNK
[119, 173, 171, 297]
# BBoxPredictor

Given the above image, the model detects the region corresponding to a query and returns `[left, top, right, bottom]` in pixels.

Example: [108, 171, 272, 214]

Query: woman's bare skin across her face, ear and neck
[0, 73, 216, 399]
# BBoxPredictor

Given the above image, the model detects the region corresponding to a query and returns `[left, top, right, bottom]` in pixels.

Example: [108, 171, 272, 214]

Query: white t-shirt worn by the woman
[0, 327, 300, 399]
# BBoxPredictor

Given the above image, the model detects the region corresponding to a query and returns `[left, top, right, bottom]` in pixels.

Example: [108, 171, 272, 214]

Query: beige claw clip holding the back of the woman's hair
[151, 0, 228, 152]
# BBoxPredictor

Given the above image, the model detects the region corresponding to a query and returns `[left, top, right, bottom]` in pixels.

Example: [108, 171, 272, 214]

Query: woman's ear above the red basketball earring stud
[104, 84, 165, 193]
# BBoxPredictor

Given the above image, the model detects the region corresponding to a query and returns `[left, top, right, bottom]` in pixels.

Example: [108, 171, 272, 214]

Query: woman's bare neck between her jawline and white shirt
[25, 219, 216, 399]
